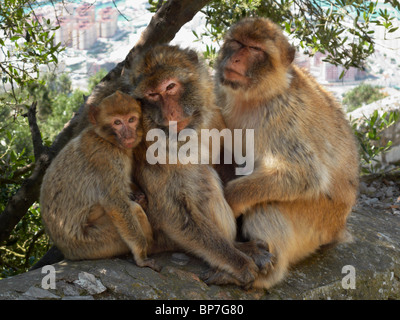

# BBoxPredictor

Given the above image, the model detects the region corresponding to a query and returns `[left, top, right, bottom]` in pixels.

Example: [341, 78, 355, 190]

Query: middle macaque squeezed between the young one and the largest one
[125, 45, 270, 286]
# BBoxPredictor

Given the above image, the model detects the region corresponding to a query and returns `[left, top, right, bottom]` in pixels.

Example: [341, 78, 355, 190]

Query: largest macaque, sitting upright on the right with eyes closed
[216, 18, 359, 288]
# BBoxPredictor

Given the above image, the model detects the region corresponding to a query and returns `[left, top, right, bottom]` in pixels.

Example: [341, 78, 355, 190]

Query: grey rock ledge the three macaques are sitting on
[0, 195, 400, 300]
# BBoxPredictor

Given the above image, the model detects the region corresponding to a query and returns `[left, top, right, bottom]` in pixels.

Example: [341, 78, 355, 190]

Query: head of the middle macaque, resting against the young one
[127, 45, 203, 131]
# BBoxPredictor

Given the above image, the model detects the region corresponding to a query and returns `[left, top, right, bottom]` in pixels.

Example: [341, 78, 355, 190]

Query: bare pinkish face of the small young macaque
[110, 112, 139, 149]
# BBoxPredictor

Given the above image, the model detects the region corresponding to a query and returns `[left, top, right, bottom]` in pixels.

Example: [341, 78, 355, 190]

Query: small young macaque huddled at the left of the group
[40, 91, 159, 270]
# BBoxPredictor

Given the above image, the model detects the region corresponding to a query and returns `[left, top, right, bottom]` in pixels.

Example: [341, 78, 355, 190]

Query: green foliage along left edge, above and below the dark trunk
[0, 0, 63, 278]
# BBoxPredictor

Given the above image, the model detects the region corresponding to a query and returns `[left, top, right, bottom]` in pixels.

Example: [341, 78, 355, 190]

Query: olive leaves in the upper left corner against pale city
[0, 0, 63, 104]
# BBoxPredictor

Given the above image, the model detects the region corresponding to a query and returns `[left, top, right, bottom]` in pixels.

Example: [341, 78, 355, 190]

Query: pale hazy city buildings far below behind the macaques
[7, 0, 400, 99]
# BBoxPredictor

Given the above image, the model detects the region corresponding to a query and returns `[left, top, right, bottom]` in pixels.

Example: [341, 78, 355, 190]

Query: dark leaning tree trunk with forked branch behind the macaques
[0, 0, 210, 244]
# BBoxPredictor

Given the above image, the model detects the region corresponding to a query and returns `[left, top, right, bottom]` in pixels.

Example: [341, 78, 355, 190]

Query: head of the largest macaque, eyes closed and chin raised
[217, 18, 295, 91]
